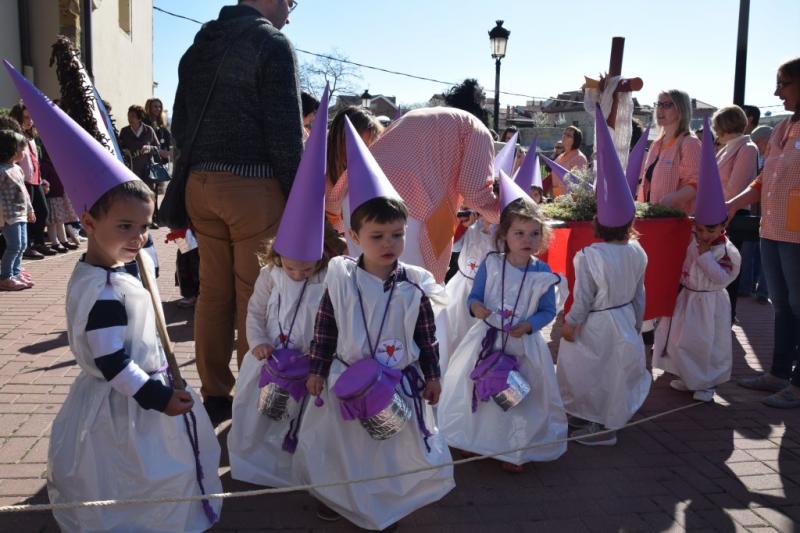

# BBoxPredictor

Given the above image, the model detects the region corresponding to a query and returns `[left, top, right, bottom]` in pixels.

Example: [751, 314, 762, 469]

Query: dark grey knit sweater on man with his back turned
[172, 5, 303, 194]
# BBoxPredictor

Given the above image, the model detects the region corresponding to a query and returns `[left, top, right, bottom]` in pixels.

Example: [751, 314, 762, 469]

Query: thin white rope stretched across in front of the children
[0, 402, 705, 514]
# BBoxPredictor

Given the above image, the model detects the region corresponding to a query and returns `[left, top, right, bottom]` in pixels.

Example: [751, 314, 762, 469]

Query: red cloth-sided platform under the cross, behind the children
[541, 218, 692, 320]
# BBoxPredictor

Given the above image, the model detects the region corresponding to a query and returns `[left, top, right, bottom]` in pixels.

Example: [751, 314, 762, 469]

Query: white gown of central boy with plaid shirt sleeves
[294, 257, 455, 530]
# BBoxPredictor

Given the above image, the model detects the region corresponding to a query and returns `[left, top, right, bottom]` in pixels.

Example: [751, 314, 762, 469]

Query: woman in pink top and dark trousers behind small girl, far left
[9, 104, 52, 259]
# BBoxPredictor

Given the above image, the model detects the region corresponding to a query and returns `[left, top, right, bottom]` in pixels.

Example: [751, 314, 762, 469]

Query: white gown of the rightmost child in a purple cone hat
[653, 239, 741, 390]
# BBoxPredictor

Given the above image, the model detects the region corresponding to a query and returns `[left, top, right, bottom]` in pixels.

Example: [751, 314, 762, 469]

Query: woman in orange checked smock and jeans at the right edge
[728, 57, 800, 408]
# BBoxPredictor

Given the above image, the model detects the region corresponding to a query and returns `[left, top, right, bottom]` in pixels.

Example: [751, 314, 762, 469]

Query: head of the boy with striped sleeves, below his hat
[81, 198, 153, 267]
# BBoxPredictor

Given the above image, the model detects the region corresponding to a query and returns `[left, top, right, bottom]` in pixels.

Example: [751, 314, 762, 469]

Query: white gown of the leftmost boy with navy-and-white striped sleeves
[47, 255, 222, 532]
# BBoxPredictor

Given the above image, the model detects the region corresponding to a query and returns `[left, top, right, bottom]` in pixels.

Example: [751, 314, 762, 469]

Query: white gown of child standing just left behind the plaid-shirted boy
[228, 267, 325, 487]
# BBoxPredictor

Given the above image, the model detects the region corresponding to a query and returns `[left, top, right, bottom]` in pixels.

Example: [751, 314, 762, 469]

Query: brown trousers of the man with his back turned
[186, 171, 286, 398]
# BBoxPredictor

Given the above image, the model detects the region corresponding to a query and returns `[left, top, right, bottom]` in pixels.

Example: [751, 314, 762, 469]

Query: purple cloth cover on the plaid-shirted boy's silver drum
[333, 358, 403, 420]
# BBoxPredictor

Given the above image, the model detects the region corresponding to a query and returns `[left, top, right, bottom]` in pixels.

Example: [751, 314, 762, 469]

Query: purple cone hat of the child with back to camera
[594, 105, 636, 228]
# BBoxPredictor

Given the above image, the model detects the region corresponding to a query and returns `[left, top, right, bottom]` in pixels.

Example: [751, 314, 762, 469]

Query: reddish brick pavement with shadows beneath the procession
[0, 230, 800, 533]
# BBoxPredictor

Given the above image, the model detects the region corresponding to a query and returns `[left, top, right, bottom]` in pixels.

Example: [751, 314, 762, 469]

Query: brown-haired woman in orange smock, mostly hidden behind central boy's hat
[325, 106, 383, 235]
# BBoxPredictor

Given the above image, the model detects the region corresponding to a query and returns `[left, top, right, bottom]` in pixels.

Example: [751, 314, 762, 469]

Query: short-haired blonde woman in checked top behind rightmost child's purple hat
[711, 105, 758, 319]
